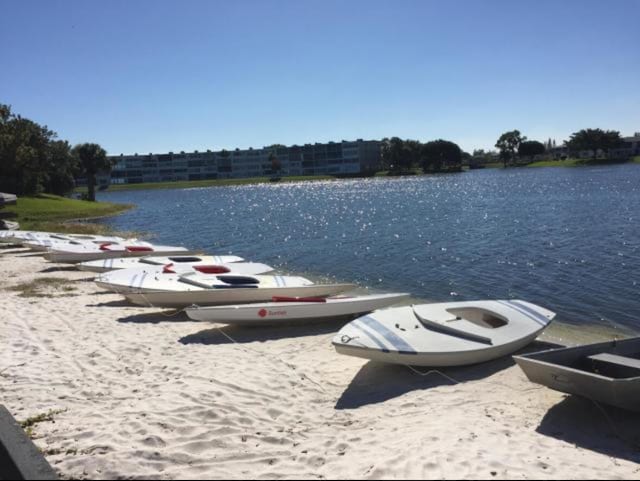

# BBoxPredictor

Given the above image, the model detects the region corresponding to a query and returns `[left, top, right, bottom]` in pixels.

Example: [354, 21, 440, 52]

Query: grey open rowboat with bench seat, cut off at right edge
[514, 337, 640, 411]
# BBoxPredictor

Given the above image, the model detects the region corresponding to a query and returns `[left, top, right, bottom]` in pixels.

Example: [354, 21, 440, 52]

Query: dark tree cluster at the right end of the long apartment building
[382, 137, 464, 174]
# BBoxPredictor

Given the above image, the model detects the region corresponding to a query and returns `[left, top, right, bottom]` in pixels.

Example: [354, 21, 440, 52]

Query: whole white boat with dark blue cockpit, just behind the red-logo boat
[115, 272, 355, 308]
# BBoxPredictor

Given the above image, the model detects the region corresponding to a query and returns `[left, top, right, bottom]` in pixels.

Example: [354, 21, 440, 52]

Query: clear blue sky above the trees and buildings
[0, 0, 640, 154]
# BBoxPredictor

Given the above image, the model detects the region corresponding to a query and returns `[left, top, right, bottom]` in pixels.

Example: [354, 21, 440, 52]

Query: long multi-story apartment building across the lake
[110, 139, 381, 184]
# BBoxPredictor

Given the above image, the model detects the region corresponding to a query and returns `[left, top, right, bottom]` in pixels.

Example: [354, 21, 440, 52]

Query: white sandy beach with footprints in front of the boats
[0, 249, 640, 479]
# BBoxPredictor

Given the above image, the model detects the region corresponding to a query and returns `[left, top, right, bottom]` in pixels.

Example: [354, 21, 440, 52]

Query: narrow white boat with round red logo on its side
[186, 294, 409, 325]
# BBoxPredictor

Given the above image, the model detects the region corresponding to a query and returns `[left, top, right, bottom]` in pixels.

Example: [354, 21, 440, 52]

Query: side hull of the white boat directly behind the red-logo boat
[122, 284, 355, 308]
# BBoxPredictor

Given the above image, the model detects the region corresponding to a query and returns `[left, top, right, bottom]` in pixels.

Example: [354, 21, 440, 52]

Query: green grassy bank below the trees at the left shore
[0, 194, 133, 234]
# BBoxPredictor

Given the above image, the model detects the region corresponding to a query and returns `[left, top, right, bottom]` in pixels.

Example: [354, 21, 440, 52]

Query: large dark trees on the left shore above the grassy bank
[0, 104, 112, 201]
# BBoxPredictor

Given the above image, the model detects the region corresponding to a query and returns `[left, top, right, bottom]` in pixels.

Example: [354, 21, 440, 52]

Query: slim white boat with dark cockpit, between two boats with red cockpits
[78, 255, 244, 273]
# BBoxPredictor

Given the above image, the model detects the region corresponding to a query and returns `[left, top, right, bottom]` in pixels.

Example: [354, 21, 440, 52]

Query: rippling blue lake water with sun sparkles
[100, 165, 640, 333]
